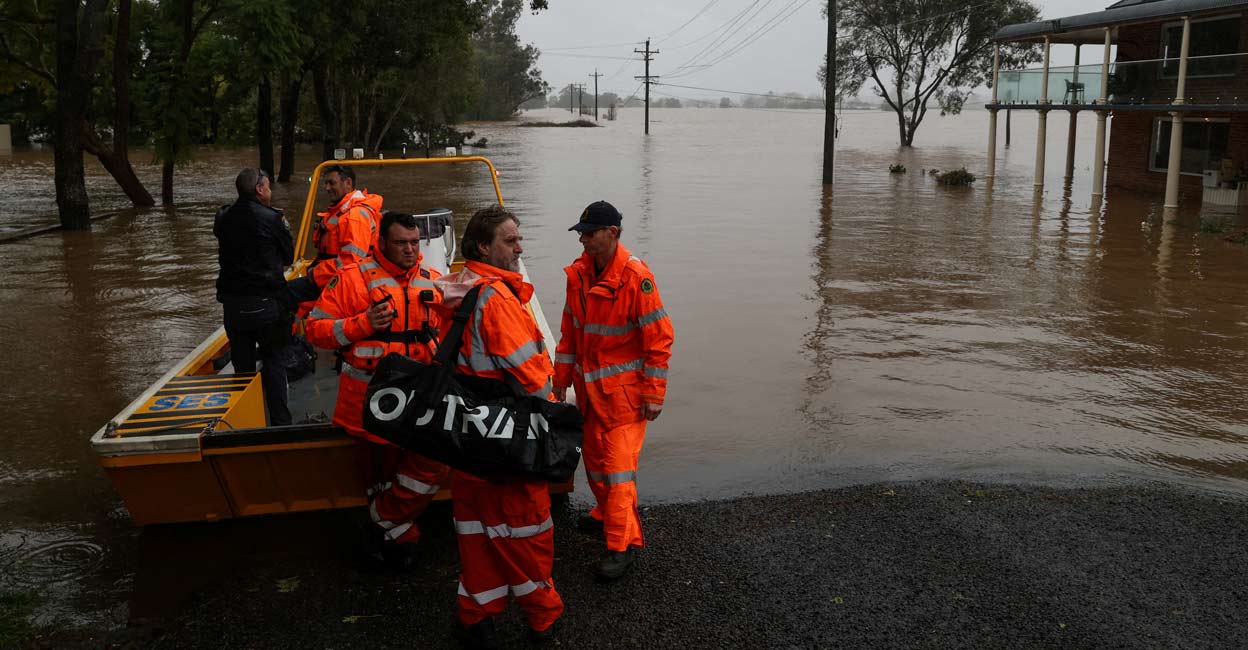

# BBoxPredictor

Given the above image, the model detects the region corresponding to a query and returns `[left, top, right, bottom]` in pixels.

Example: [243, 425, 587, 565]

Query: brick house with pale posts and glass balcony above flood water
[987, 0, 1248, 208]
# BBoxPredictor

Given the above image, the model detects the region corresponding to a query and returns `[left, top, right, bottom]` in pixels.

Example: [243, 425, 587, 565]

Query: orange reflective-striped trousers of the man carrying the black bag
[451, 470, 563, 631]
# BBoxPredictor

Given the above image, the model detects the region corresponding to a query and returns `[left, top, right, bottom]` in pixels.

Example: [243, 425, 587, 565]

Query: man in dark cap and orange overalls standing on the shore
[554, 201, 673, 580]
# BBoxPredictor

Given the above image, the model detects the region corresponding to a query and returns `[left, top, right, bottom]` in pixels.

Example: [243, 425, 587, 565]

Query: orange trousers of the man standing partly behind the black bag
[357, 440, 449, 544]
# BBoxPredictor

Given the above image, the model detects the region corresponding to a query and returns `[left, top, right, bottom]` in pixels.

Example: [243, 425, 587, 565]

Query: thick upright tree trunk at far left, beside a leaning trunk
[52, 0, 107, 230]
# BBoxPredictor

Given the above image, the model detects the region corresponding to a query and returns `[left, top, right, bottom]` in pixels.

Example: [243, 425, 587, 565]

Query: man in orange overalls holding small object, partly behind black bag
[307, 212, 448, 568]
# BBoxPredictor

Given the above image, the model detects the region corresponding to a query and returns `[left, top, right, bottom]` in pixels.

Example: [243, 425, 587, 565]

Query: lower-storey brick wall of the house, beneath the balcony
[1106, 112, 1248, 198]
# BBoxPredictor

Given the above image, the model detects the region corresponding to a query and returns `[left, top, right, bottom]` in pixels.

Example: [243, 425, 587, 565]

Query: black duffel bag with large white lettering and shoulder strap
[364, 286, 583, 483]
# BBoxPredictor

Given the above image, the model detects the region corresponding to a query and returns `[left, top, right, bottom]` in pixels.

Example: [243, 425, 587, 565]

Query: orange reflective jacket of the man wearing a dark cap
[554, 245, 674, 427]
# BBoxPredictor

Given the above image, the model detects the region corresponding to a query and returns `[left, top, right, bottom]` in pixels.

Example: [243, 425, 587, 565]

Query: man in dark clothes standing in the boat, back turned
[212, 167, 295, 425]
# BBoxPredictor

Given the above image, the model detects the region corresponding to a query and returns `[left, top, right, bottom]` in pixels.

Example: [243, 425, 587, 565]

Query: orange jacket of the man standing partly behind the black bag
[307, 250, 442, 442]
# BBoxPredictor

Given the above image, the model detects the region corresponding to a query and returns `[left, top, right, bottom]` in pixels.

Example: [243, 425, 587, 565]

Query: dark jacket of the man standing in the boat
[212, 198, 295, 303]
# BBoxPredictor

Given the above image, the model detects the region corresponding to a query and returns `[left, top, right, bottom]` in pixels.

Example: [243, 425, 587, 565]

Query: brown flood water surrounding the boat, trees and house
[0, 109, 1248, 625]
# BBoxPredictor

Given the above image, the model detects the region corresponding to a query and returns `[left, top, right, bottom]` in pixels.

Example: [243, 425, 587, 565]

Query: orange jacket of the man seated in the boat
[308, 190, 382, 288]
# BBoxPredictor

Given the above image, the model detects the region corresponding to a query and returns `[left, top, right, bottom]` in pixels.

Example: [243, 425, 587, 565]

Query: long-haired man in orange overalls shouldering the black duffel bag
[438, 206, 563, 649]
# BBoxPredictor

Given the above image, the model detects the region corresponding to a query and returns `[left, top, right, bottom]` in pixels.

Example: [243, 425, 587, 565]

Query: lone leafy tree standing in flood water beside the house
[819, 0, 1040, 147]
